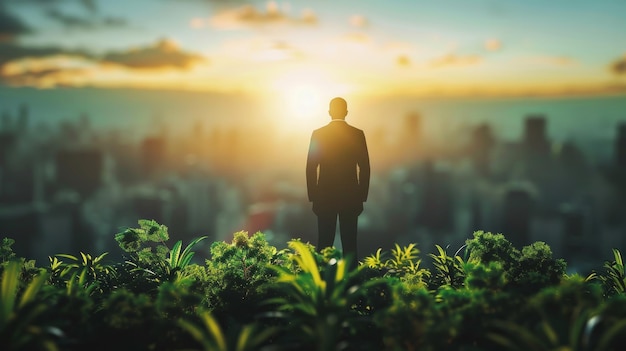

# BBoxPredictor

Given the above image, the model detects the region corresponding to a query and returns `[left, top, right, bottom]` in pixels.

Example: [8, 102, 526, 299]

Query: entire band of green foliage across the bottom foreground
[0, 220, 626, 351]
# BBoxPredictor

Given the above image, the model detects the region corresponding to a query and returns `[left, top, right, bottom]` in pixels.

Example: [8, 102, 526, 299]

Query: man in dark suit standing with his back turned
[306, 97, 370, 263]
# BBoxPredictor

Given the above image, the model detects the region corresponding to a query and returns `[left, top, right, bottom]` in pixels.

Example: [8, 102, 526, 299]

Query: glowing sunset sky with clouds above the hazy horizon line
[0, 0, 626, 100]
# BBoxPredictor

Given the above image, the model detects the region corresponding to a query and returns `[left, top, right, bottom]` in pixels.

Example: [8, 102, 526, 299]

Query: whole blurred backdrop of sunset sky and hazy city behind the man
[0, 0, 626, 271]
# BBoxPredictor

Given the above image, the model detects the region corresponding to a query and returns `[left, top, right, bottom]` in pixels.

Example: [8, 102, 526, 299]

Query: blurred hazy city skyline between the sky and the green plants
[0, 105, 626, 272]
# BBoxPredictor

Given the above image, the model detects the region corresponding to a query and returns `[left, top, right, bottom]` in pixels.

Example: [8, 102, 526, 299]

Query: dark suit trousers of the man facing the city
[317, 211, 359, 261]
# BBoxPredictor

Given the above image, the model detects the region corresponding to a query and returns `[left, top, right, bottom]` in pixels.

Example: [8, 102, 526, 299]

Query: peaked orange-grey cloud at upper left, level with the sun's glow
[102, 39, 206, 70]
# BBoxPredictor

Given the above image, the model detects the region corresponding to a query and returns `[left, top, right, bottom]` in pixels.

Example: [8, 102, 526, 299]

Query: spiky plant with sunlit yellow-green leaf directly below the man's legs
[266, 241, 386, 351]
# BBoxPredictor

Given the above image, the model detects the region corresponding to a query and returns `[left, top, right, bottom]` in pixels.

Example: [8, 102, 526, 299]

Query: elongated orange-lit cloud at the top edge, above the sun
[208, 1, 318, 29]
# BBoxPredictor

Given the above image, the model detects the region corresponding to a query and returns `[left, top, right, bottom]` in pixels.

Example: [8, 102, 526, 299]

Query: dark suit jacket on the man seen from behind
[306, 120, 370, 214]
